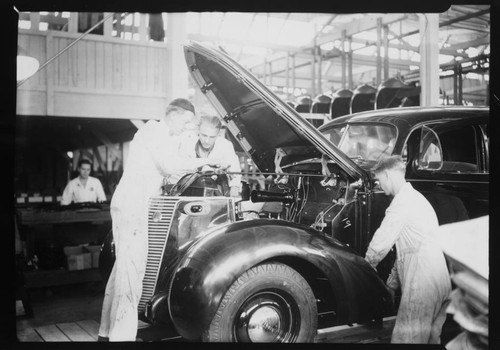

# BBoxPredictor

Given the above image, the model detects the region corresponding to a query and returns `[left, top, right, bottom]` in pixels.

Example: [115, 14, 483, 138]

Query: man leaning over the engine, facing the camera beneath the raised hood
[178, 115, 241, 197]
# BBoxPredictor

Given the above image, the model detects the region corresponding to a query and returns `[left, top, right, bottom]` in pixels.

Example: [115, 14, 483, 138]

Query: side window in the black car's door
[418, 124, 480, 173]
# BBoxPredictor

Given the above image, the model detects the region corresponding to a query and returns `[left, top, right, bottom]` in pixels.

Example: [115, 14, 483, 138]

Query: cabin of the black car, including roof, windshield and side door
[319, 106, 489, 225]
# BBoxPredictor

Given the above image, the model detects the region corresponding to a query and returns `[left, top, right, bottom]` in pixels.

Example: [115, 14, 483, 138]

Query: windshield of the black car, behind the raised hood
[324, 124, 397, 161]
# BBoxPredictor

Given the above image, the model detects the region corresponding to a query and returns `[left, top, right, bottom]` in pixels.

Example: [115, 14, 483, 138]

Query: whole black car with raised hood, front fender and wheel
[101, 43, 488, 342]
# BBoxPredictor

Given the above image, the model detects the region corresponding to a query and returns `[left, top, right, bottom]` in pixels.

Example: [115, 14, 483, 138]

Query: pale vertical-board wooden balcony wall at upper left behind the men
[17, 29, 168, 119]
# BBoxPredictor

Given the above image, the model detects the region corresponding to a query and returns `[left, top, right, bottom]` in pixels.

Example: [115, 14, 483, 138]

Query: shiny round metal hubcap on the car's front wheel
[233, 290, 300, 343]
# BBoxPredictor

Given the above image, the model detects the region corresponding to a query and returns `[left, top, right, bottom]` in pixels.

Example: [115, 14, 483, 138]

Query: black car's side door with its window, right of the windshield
[406, 118, 489, 224]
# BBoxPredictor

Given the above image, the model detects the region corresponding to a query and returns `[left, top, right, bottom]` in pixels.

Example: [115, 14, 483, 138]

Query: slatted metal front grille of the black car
[139, 197, 179, 311]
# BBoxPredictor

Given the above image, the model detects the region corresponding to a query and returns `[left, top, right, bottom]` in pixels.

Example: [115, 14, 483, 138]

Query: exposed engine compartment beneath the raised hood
[164, 159, 360, 245]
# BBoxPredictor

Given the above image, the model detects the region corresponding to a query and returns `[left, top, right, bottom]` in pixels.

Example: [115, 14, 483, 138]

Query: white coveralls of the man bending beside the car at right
[365, 183, 451, 344]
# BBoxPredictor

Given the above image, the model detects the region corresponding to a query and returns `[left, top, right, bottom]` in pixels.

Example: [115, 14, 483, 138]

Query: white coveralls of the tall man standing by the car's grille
[99, 120, 201, 341]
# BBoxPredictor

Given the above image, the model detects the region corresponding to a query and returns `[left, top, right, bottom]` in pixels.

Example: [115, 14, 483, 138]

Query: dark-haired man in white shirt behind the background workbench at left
[61, 159, 106, 205]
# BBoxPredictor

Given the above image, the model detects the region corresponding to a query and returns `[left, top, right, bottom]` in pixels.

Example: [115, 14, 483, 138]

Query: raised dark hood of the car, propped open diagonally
[184, 42, 366, 178]
